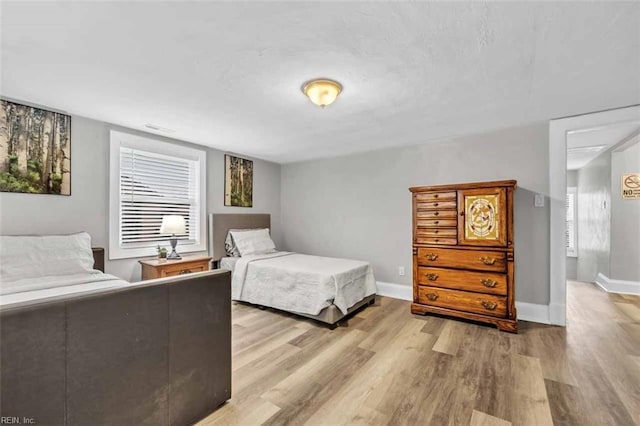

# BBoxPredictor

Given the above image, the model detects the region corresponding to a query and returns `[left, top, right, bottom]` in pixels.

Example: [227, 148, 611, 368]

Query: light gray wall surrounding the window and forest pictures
[0, 116, 282, 281]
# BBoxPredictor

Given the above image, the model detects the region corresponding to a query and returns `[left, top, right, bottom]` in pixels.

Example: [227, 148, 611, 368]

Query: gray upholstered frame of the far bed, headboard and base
[209, 214, 376, 328]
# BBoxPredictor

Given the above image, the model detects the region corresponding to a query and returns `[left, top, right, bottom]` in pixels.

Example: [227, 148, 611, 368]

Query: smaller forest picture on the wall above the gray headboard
[224, 154, 253, 207]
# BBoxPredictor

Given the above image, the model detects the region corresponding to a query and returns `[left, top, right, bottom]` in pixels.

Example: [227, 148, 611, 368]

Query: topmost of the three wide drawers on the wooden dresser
[418, 248, 507, 272]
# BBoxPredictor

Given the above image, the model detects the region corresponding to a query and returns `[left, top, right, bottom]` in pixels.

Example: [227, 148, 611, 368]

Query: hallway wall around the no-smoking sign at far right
[609, 143, 640, 282]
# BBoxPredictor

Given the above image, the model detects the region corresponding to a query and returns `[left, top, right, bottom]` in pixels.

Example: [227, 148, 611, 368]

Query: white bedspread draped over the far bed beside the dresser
[232, 252, 377, 315]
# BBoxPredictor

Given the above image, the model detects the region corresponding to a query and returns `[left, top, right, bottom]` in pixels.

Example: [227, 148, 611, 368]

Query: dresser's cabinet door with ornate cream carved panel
[458, 188, 507, 247]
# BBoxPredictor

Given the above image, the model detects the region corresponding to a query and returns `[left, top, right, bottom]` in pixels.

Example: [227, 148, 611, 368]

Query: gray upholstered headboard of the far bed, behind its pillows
[209, 213, 271, 260]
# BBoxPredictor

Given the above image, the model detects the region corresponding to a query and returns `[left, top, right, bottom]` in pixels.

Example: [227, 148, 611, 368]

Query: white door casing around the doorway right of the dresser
[549, 105, 640, 325]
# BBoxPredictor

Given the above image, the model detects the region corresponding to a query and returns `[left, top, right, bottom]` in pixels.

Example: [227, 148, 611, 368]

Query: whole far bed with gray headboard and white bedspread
[209, 214, 377, 327]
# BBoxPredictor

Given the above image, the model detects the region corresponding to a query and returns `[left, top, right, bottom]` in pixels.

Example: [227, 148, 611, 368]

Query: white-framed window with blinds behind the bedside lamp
[109, 131, 206, 259]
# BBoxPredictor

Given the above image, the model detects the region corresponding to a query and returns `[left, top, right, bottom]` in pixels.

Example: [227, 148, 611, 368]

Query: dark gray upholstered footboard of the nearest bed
[0, 270, 231, 426]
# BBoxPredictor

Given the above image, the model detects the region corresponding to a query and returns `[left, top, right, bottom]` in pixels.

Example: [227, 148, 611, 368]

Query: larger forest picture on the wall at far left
[0, 100, 71, 195]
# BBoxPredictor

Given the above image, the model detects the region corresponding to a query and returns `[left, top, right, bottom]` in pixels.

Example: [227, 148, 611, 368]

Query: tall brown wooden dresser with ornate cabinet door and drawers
[409, 180, 518, 333]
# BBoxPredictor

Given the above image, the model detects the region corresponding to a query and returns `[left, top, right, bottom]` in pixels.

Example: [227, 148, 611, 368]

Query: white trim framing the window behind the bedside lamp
[108, 129, 207, 260]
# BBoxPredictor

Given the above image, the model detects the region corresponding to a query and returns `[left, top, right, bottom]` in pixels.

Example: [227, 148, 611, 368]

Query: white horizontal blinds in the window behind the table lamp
[120, 147, 200, 247]
